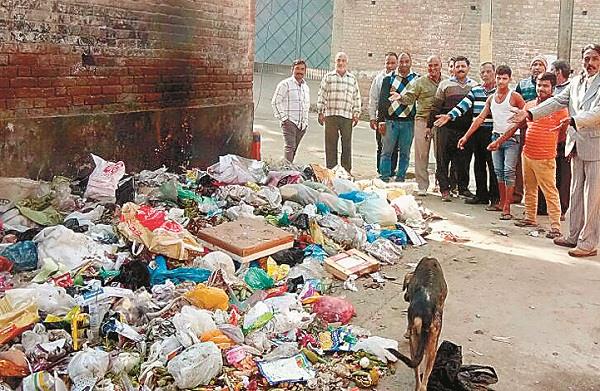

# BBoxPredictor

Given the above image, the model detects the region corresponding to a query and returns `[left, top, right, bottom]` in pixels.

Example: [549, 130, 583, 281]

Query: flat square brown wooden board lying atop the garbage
[196, 218, 294, 262]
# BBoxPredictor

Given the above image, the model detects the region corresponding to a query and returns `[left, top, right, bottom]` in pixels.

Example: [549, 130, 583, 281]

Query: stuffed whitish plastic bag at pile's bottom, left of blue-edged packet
[167, 342, 223, 389]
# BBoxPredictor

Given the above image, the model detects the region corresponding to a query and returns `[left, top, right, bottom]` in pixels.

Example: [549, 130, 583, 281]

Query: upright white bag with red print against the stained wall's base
[84, 154, 125, 203]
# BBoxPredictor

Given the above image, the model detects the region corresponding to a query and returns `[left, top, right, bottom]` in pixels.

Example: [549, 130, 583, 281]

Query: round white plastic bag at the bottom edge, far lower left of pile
[67, 348, 110, 391]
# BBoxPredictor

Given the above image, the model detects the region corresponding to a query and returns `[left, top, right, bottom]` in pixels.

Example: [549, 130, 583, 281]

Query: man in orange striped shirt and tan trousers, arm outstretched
[515, 72, 569, 239]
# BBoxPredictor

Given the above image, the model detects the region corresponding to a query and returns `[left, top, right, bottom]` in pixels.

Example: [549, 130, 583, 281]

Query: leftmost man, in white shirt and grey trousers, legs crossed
[271, 59, 310, 163]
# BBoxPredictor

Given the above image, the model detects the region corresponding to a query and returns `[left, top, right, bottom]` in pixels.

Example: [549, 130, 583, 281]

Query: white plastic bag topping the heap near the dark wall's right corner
[206, 155, 267, 185]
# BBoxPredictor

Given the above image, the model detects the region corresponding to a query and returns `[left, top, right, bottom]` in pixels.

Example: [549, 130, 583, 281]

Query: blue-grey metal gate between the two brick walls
[255, 0, 333, 69]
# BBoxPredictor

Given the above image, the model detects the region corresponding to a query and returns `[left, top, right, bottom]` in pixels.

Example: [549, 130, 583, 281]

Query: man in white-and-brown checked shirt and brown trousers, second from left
[317, 52, 361, 172]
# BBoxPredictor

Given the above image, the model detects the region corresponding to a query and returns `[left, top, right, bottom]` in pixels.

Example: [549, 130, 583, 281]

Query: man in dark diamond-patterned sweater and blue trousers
[377, 53, 419, 182]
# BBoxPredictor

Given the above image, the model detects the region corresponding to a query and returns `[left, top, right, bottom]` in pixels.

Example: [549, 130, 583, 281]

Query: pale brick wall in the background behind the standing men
[332, 0, 600, 86]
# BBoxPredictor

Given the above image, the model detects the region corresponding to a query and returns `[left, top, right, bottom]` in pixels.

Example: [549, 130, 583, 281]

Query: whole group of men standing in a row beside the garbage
[272, 45, 600, 257]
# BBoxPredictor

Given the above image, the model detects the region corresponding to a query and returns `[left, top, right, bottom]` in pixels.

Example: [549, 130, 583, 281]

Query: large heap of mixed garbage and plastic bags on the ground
[0, 155, 428, 391]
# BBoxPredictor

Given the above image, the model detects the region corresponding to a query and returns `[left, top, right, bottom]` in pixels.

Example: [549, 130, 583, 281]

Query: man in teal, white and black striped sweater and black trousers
[435, 62, 500, 210]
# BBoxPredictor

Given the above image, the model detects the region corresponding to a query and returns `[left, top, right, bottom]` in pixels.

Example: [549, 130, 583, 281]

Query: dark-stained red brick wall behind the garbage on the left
[0, 0, 255, 176]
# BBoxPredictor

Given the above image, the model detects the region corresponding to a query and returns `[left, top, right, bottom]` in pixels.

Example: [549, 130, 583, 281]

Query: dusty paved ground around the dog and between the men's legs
[255, 75, 600, 391]
